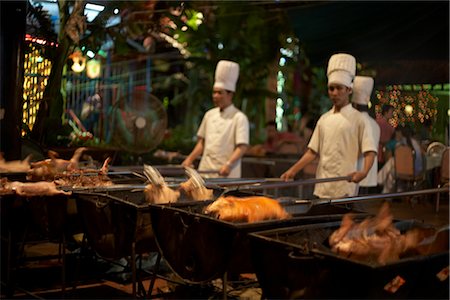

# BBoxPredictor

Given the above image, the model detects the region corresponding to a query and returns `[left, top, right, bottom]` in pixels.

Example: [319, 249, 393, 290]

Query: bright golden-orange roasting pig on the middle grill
[204, 196, 290, 223]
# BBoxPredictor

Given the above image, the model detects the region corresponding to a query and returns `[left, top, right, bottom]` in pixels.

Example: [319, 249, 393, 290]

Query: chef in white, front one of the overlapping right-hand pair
[281, 53, 377, 199]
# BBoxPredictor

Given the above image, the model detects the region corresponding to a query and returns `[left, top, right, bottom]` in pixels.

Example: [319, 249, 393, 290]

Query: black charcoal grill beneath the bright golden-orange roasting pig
[150, 190, 367, 284]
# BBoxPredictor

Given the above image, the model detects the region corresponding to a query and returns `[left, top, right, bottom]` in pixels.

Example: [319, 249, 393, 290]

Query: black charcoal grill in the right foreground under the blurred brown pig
[249, 220, 449, 299]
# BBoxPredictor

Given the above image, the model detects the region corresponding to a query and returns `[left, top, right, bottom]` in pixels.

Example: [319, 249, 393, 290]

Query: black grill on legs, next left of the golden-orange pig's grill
[70, 185, 229, 296]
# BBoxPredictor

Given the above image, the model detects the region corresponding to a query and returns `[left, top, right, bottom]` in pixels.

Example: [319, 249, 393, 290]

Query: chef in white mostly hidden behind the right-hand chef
[352, 76, 380, 195]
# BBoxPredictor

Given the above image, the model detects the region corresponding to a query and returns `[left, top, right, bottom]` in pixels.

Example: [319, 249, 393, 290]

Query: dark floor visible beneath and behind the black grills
[1, 194, 449, 299]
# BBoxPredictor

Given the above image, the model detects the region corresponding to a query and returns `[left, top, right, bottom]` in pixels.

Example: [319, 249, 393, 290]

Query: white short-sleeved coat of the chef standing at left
[197, 104, 250, 178]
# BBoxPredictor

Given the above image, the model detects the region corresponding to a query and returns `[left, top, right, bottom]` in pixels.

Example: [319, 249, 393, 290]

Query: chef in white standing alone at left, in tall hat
[182, 60, 250, 178]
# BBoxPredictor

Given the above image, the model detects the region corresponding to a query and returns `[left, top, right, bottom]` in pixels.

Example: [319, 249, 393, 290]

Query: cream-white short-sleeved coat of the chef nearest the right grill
[308, 103, 378, 198]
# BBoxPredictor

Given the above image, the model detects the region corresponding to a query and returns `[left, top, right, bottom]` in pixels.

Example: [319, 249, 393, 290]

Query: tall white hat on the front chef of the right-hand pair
[327, 53, 356, 87]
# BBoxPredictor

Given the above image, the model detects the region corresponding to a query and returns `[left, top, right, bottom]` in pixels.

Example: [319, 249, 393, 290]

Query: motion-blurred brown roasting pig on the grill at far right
[329, 202, 424, 265]
